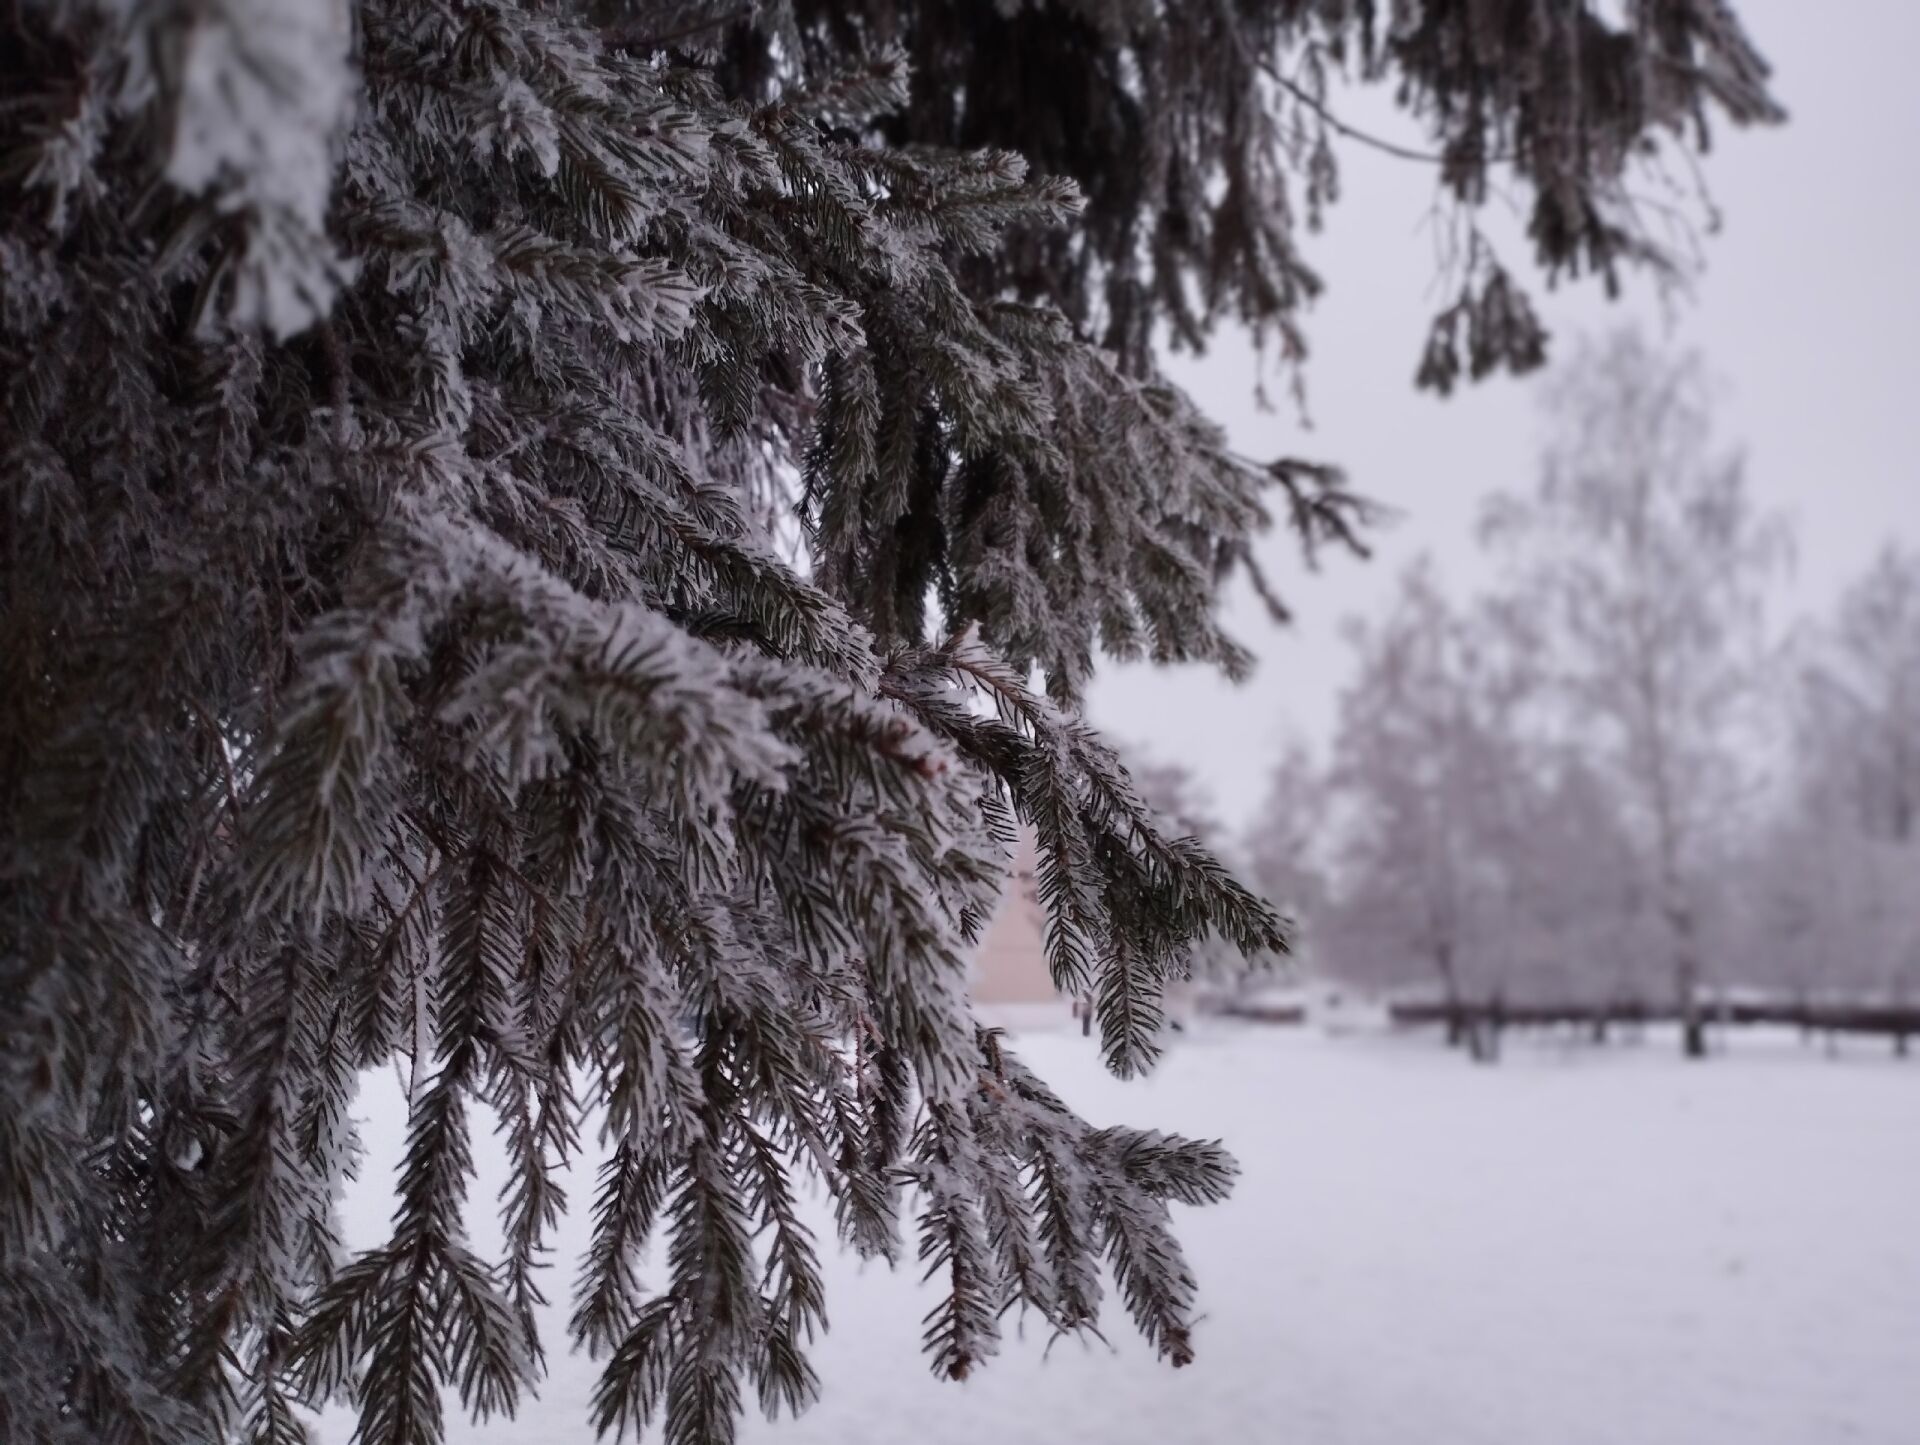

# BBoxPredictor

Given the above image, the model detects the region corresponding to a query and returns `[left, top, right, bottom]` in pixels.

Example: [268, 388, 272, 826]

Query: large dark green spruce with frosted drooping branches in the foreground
[0, 0, 1774, 1445]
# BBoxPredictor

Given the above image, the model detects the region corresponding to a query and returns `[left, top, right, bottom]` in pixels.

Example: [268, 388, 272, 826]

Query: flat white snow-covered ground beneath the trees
[337, 1030, 1920, 1445]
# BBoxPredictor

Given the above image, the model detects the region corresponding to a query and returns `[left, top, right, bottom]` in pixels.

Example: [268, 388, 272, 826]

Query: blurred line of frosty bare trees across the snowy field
[1198, 332, 1920, 1054]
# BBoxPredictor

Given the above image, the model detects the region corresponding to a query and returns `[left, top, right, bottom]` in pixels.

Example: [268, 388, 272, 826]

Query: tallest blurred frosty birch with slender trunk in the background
[1484, 332, 1786, 1057]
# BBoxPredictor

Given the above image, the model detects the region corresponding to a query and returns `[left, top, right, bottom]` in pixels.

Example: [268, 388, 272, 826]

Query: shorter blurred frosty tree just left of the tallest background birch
[1311, 560, 1651, 1040]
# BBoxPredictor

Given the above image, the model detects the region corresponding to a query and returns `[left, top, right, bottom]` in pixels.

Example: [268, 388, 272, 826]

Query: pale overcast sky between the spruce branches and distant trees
[1091, 0, 1920, 823]
